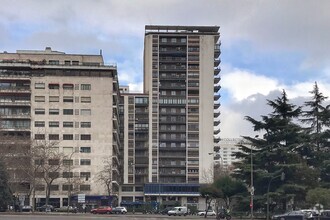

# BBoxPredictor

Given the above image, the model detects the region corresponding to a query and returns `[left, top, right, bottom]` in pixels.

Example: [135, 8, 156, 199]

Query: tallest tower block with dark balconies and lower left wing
[120, 26, 220, 209]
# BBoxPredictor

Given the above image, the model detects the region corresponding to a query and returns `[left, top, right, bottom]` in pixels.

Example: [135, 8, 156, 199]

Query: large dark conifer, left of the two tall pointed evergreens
[234, 91, 317, 212]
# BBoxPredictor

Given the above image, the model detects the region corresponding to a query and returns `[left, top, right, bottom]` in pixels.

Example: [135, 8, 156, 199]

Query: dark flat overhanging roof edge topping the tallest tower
[145, 25, 220, 35]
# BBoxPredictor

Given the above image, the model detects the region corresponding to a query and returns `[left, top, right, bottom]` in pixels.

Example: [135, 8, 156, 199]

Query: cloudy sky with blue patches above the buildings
[0, 0, 330, 138]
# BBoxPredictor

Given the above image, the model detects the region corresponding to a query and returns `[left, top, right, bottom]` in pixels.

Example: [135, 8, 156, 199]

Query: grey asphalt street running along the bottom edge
[0, 213, 219, 220]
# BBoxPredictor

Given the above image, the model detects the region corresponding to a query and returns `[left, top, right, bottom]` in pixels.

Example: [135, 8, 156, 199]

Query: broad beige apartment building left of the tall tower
[0, 48, 120, 206]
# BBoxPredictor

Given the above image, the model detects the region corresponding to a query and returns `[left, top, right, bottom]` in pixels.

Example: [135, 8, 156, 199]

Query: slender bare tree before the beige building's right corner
[96, 158, 113, 205]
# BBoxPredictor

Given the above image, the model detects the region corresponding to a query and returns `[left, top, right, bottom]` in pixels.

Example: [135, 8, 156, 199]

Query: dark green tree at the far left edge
[0, 159, 12, 208]
